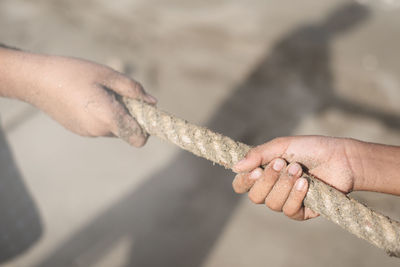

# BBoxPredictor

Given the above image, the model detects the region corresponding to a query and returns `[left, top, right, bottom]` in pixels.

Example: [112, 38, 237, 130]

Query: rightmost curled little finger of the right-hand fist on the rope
[282, 177, 308, 219]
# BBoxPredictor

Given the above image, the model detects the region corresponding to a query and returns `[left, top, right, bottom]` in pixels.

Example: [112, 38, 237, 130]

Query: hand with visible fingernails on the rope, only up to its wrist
[233, 136, 356, 220]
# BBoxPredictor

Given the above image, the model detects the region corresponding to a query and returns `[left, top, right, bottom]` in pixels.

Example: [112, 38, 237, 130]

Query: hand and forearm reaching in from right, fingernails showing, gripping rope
[233, 136, 400, 220]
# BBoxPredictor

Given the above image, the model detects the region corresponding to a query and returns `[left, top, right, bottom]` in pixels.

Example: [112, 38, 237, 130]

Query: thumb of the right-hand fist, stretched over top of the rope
[233, 137, 290, 173]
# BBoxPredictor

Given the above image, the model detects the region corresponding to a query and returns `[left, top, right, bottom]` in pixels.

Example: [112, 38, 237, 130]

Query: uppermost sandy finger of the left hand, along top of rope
[105, 73, 157, 105]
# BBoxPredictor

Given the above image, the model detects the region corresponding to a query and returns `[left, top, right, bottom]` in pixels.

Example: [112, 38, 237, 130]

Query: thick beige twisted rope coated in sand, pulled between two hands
[123, 98, 400, 257]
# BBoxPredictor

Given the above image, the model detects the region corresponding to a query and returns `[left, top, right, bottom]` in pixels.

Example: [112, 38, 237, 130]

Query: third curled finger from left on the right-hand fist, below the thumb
[265, 163, 302, 211]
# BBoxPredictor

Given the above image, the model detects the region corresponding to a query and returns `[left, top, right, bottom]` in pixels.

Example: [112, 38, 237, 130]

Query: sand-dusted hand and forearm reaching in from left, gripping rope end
[0, 48, 156, 147]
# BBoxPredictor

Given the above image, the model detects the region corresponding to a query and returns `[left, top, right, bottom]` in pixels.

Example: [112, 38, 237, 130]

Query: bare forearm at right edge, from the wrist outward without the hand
[349, 140, 400, 195]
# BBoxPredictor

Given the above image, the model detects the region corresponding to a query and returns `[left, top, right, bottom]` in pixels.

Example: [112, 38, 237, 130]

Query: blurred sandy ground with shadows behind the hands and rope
[0, 0, 400, 267]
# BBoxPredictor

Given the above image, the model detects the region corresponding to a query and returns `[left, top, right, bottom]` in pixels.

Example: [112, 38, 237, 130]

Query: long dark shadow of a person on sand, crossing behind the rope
[26, 4, 400, 267]
